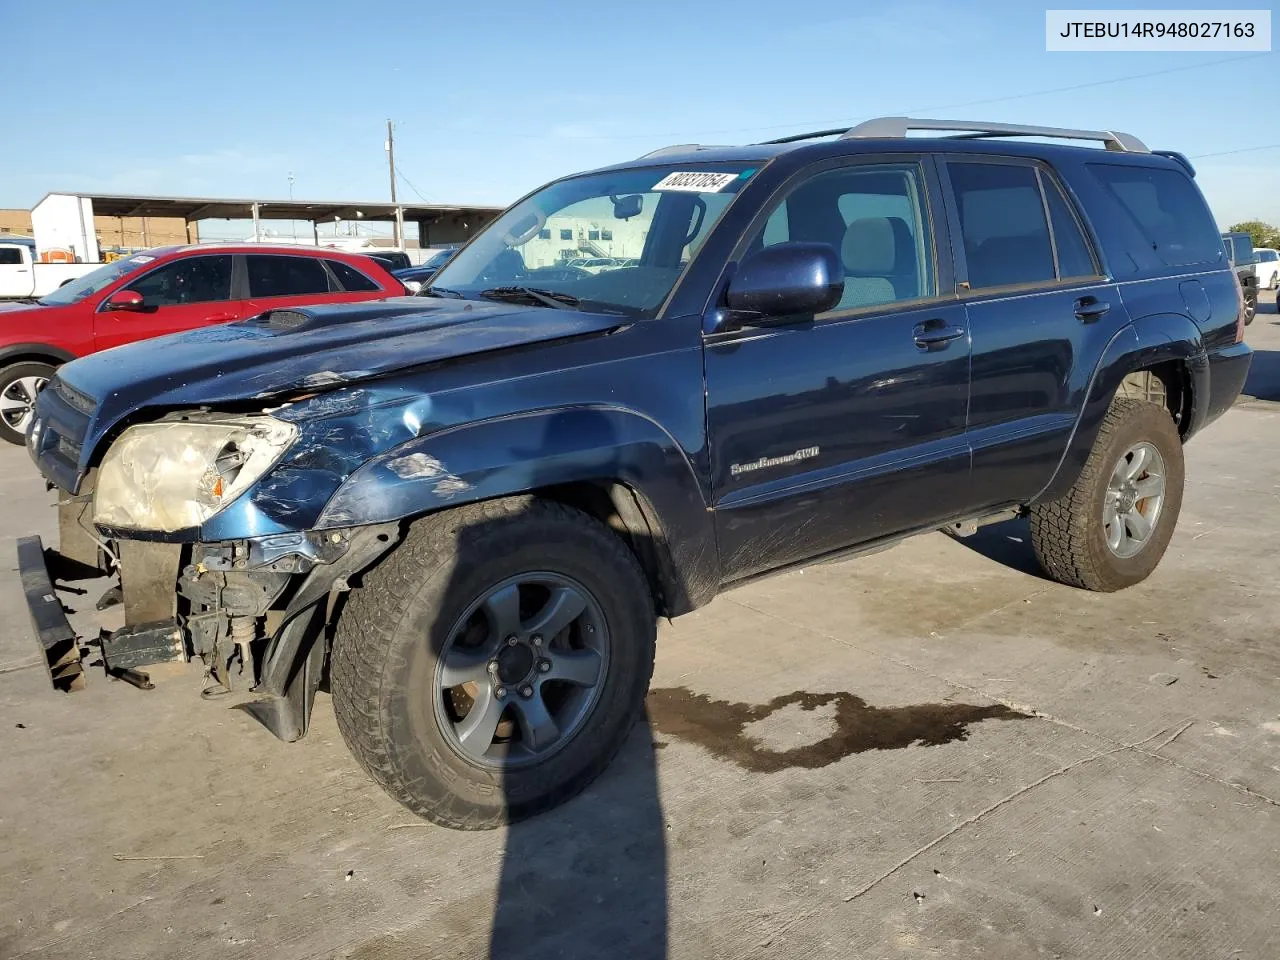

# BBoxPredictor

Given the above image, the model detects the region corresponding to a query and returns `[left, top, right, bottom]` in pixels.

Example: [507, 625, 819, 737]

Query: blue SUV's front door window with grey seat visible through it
[749, 164, 934, 310]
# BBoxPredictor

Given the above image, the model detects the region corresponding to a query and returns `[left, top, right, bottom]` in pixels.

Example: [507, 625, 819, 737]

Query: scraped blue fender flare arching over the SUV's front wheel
[316, 404, 719, 616]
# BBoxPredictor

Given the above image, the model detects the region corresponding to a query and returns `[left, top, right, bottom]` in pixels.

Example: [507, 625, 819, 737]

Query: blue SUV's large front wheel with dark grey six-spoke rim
[332, 498, 655, 829]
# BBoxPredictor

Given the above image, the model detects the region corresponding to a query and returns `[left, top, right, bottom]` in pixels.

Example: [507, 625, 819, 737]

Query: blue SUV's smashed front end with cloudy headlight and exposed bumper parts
[18, 401, 401, 740]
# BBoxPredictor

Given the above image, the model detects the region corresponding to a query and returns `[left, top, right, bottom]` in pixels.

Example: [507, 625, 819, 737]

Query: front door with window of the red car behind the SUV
[93, 253, 246, 349]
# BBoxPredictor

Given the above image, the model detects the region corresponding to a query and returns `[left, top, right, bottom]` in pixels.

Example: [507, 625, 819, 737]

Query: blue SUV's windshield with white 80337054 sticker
[424, 164, 756, 316]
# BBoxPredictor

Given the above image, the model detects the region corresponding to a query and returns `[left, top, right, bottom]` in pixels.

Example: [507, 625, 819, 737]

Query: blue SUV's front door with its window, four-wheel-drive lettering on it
[705, 160, 969, 580]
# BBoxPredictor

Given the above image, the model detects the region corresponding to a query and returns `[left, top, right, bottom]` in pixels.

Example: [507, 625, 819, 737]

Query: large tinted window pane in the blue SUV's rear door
[947, 163, 1057, 289]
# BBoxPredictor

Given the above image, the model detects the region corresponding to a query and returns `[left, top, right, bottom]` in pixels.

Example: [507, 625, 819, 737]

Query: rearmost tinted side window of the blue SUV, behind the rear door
[1089, 164, 1222, 266]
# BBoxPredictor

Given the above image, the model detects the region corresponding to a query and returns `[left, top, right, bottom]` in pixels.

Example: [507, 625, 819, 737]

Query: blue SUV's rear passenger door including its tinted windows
[943, 155, 1126, 506]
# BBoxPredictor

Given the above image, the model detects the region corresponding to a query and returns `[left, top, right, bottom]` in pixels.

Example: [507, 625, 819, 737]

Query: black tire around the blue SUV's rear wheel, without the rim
[1030, 397, 1184, 593]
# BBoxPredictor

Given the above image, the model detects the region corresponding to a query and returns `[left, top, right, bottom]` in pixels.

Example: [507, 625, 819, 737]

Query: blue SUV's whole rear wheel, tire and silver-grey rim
[1030, 397, 1184, 593]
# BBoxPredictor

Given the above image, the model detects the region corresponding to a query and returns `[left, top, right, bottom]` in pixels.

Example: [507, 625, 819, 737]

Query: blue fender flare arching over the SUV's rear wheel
[1030, 314, 1208, 503]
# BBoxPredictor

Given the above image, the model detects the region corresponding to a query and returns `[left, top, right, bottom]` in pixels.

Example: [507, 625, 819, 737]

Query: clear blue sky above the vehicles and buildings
[0, 0, 1280, 232]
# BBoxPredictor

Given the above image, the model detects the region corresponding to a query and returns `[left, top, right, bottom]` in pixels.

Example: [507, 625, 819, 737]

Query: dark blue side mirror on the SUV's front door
[727, 241, 845, 321]
